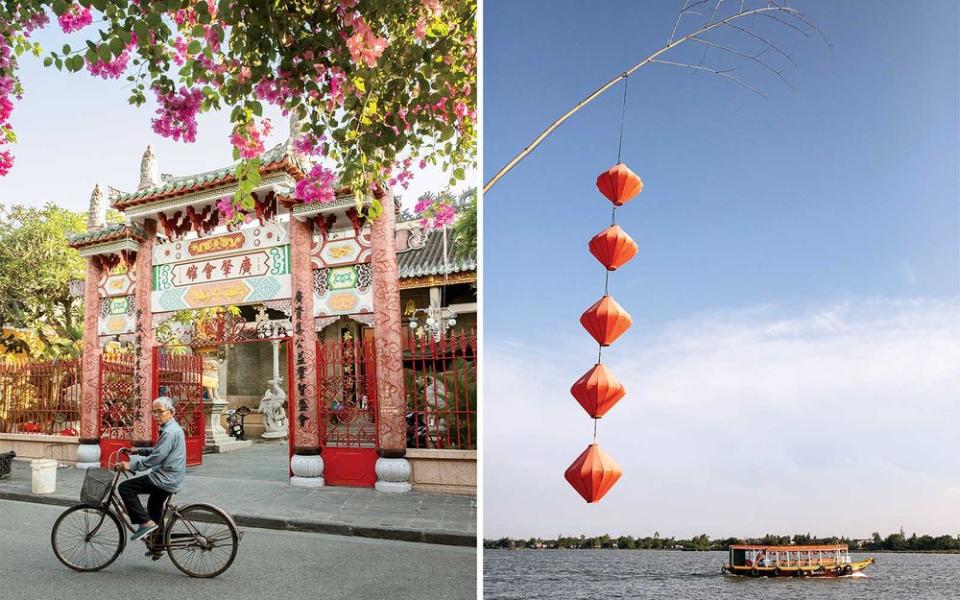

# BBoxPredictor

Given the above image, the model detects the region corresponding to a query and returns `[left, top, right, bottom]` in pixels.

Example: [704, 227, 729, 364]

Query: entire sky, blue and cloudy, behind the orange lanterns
[483, 0, 960, 537]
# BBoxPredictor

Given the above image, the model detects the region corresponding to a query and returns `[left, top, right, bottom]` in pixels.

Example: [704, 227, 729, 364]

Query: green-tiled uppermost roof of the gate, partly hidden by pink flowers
[110, 140, 307, 210]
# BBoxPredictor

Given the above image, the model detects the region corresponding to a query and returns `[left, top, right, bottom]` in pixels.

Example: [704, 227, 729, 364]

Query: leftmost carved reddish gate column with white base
[77, 256, 103, 468]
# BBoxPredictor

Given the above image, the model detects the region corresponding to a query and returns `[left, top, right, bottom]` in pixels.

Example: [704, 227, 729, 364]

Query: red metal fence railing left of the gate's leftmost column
[0, 360, 80, 436]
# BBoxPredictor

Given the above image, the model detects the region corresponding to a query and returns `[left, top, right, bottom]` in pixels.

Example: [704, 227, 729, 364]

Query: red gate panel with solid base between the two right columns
[314, 338, 378, 486]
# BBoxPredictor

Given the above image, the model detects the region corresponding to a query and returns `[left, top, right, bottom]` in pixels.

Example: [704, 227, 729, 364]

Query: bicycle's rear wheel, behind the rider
[164, 504, 240, 577]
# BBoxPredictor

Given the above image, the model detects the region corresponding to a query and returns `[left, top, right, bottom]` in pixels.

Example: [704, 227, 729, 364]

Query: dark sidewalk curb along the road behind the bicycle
[0, 490, 477, 547]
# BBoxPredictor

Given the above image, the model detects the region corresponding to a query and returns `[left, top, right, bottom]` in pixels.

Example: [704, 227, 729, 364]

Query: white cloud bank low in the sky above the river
[484, 300, 960, 537]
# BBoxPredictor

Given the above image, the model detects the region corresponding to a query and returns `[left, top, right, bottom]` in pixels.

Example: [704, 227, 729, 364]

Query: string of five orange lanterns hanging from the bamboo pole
[563, 162, 643, 502]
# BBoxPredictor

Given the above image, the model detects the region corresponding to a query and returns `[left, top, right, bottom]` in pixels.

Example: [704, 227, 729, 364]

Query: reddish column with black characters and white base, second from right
[289, 217, 323, 487]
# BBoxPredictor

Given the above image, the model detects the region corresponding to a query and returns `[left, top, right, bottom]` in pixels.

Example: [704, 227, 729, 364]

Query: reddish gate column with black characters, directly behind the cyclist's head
[133, 219, 157, 447]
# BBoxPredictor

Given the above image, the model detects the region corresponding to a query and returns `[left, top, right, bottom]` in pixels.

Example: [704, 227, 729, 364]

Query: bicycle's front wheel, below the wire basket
[50, 505, 126, 571]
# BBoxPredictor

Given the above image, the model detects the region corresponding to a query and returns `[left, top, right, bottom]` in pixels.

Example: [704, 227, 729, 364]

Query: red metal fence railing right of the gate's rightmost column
[403, 330, 477, 450]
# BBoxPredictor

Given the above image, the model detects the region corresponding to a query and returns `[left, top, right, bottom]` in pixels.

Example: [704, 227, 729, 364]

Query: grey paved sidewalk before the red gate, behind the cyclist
[0, 443, 477, 546]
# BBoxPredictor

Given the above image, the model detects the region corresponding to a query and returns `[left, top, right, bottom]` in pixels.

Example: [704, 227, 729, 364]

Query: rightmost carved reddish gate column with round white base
[370, 191, 411, 492]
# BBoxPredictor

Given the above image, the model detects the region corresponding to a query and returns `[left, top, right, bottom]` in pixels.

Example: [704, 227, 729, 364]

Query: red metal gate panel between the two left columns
[98, 354, 135, 467]
